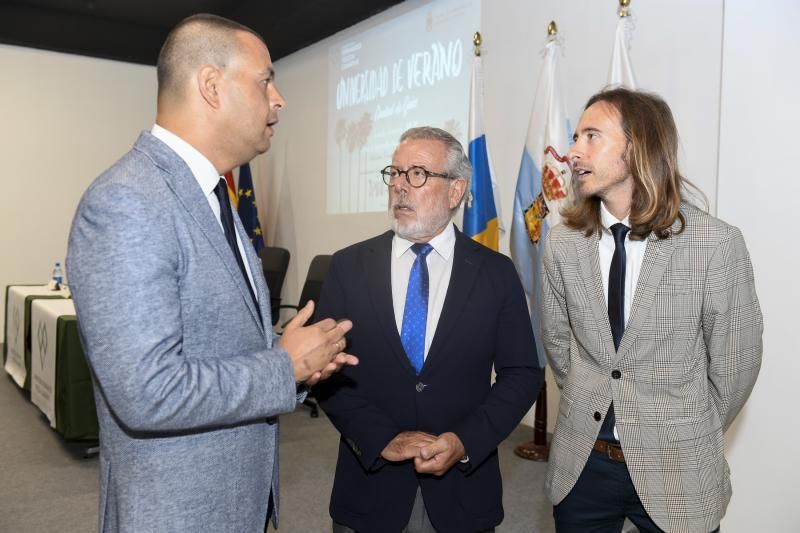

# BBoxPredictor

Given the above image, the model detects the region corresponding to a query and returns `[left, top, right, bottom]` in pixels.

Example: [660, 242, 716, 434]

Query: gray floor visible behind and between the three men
[0, 372, 554, 533]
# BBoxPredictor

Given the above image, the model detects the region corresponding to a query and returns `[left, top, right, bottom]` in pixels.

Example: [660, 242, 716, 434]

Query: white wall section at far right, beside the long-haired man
[718, 0, 800, 533]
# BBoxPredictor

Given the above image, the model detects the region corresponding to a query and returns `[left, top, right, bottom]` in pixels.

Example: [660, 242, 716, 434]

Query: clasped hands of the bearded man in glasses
[381, 431, 465, 476]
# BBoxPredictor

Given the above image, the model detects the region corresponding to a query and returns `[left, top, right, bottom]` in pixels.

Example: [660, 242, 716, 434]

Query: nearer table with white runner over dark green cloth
[30, 299, 97, 440]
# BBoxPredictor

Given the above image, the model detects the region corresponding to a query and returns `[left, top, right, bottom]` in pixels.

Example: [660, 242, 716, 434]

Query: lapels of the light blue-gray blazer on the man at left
[135, 132, 269, 334]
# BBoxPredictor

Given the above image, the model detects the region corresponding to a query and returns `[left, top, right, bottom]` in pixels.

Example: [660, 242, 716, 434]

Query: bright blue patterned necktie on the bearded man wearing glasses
[400, 243, 433, 375]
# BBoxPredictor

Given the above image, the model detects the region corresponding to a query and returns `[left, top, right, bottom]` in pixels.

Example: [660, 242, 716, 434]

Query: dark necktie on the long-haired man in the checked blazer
[598, 220, 630, 442]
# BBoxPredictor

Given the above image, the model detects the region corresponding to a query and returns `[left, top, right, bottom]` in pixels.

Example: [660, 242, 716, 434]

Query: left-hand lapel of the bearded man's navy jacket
[360, 231, 416, 376]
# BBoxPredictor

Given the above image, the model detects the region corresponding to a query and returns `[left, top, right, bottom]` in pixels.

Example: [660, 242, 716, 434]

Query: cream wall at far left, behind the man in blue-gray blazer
[0, 45, 156, 324]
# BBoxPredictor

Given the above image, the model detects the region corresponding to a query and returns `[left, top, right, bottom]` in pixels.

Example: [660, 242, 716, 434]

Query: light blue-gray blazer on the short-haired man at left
[67, 133, 296, 533]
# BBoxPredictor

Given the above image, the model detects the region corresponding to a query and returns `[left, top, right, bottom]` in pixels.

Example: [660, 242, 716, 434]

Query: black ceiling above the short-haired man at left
[0, 0, 402, 65]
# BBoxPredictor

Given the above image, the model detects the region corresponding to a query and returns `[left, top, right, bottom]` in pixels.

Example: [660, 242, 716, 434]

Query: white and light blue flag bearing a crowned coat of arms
[511, 35, 572, 366]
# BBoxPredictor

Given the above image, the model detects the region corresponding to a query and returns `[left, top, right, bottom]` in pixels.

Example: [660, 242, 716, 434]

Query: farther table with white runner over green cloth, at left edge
[3, 285, 69, 390]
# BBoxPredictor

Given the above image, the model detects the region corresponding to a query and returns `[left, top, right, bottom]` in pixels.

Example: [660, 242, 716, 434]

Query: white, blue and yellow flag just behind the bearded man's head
[463, 51, 504, 251]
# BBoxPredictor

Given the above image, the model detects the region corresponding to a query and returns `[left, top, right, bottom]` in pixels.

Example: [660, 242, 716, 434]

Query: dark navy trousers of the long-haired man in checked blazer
[553, 451, 719, 533]
